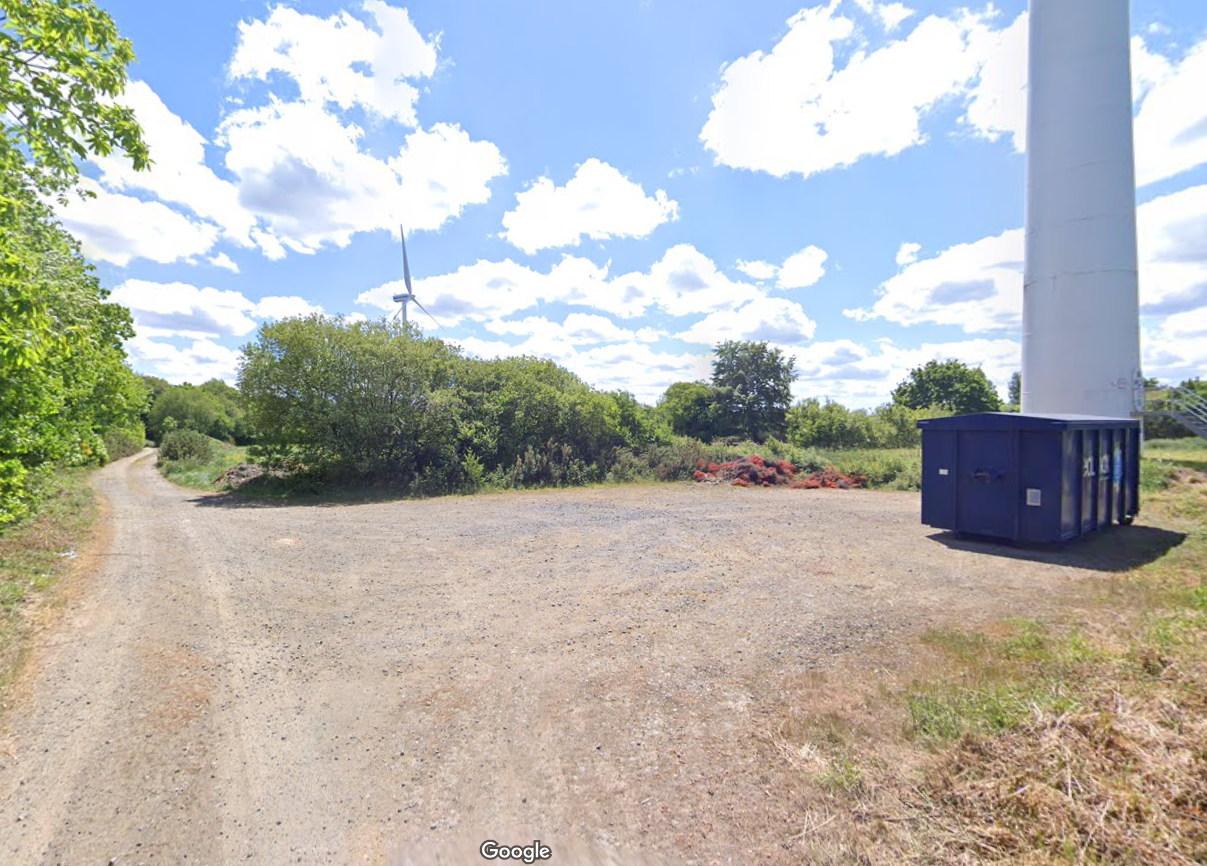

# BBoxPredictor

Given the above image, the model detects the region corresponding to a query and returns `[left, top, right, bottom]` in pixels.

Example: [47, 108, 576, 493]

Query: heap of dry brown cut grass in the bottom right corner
[927, 666, 1207, 864]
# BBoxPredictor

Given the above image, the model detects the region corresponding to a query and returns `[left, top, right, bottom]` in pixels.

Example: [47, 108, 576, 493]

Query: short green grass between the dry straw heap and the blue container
[904, 440, 1207, 740]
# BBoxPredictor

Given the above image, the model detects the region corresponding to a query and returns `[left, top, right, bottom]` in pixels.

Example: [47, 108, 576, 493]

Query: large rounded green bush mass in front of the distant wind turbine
[239, 315, 667, 493]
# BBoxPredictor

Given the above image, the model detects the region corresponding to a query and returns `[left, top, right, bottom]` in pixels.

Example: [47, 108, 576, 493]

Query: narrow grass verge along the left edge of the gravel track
[0, 469, 98, 693]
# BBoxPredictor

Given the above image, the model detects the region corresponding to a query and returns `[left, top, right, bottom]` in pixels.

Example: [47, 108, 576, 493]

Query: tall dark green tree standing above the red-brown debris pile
[712, 341, 797, 442]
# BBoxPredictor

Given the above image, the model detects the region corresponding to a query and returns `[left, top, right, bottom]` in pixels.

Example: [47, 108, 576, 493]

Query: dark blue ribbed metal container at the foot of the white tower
[917, 412, 1139, 544]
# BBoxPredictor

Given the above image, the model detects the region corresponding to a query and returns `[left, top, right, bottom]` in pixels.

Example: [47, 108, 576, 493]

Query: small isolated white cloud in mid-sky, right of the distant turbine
[501, 158, 678, 255]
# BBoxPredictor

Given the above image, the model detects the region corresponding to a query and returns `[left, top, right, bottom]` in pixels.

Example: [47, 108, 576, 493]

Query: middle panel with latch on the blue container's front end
[956, 430, 1019, 539]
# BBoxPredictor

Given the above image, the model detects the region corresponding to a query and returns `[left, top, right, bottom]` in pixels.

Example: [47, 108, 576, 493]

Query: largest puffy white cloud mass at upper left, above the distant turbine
[64, 0, 507, 267]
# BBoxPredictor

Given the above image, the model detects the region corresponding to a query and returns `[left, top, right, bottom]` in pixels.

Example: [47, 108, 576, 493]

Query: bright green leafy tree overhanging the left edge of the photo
[0, 0, 150, 523]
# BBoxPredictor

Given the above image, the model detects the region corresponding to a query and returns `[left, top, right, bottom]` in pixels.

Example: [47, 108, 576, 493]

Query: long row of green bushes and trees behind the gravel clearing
[160, 315, 1001, 493]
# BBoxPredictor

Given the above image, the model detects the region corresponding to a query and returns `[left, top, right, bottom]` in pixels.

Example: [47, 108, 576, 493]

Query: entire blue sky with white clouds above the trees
[60, 0, 1207, 406]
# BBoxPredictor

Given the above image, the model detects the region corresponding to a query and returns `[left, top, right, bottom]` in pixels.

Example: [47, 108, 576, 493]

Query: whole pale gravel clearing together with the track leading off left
[0, 452, 1120, 864]
